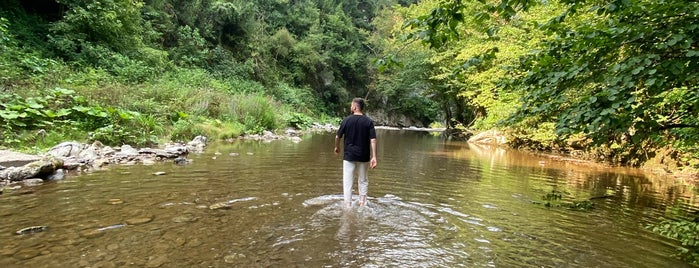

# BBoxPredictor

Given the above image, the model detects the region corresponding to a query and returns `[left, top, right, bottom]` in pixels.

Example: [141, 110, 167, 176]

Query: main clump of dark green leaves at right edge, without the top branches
[504, 1, 699, 165]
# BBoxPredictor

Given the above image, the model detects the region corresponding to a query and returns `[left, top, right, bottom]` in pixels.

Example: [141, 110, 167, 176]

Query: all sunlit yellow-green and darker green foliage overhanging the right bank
[396, 0, 699, 168]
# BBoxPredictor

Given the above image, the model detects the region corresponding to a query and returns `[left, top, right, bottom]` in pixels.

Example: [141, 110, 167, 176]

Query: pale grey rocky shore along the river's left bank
[0, 123, 337, 194]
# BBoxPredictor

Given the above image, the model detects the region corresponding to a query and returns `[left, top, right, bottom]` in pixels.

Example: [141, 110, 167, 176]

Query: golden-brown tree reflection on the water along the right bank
[426, 135, 697, 208]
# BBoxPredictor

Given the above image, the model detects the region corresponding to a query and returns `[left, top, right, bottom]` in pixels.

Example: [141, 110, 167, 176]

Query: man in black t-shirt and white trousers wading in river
[335, 98, 376, 208]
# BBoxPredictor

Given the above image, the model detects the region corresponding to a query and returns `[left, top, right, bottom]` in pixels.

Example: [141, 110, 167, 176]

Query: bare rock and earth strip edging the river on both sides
[0, 123, 699, 193]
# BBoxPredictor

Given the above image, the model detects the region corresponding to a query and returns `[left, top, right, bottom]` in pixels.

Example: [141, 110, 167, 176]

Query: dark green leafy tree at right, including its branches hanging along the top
[400, 0, 699, 163]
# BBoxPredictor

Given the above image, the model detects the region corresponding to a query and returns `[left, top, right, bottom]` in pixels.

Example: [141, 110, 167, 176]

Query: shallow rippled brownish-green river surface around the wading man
[0, 130, 696, 267]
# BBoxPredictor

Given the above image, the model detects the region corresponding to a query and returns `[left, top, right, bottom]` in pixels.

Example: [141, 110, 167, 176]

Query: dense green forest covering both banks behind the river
[0, 0, 699, 170]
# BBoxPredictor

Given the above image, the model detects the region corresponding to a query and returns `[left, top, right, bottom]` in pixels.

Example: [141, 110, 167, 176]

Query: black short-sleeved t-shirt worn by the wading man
[337, 115, 376, 162]
